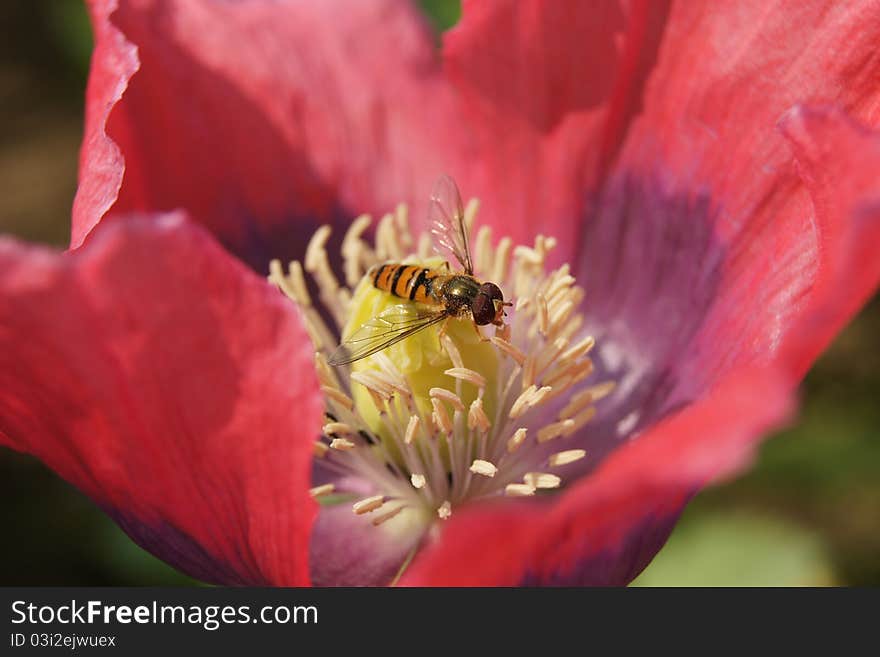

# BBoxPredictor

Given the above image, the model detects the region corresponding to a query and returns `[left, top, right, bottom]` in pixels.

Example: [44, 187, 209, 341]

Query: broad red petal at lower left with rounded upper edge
[0, 217, 323, 584]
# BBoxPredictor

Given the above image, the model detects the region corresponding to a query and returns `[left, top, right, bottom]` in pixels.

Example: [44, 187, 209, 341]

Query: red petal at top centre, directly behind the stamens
[444, 0, 667, 261]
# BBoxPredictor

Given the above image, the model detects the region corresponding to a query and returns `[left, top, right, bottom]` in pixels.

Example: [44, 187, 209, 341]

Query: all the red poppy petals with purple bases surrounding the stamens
[0, 0, 880, 585]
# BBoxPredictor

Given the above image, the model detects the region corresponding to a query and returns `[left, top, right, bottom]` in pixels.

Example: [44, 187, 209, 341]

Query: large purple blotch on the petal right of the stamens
[568, 175, 726, 478]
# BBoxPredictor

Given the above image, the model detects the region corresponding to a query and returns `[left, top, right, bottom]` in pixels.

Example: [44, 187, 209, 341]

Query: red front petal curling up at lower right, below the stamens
[403, 369, 793, 586]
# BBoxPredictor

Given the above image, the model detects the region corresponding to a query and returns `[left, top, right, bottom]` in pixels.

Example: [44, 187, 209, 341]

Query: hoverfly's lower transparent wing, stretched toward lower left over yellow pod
[328, 304, 448, 366]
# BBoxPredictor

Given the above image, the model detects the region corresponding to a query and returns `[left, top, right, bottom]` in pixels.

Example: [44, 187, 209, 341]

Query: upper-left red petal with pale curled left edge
[72, 0, 450, 270]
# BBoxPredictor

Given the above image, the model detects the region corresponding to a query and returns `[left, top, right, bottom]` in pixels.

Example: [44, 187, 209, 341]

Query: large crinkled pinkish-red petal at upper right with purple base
[576, 2, 880, 380]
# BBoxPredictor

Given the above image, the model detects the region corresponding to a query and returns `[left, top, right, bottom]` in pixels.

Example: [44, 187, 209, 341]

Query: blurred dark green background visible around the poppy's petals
[0, 0, 880, 586]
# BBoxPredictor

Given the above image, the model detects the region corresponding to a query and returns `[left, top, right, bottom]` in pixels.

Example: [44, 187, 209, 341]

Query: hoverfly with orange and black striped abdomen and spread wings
[328, 176, 513, 365]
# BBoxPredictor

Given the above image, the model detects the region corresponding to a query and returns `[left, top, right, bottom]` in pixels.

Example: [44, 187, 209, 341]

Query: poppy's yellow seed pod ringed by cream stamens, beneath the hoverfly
[269, 197, 613, 525]
